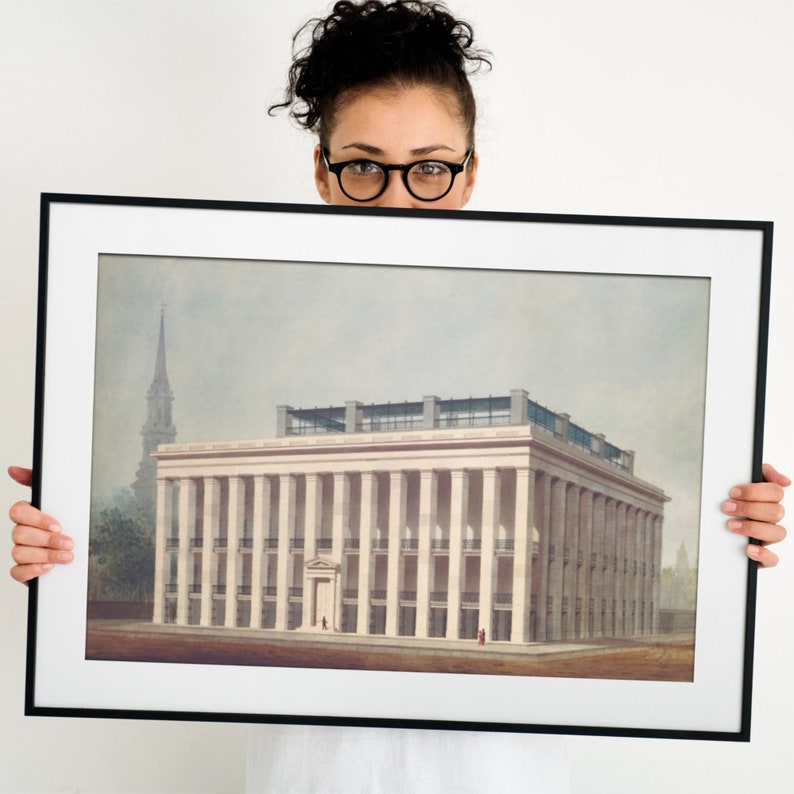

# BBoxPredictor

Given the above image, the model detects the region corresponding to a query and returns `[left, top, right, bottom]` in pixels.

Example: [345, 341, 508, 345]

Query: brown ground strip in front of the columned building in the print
[86, 620, 694, 681]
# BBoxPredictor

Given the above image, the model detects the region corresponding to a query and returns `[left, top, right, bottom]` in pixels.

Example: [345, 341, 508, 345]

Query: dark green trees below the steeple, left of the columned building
[89, 490, 155, 601]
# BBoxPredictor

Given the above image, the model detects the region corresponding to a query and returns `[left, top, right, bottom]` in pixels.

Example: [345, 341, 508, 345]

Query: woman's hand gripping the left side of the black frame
[8, 466, 74, 582]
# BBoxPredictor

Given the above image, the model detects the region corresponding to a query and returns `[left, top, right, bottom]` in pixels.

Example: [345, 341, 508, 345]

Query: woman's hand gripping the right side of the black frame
[722, 463, 791, 568]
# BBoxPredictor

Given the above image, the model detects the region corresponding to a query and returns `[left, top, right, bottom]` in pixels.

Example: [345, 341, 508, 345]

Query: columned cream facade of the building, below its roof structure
[154, 454, 666, 643]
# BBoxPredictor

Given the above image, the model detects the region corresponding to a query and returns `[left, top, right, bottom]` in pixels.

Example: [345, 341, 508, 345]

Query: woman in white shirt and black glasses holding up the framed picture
[4, 2, 790, 791]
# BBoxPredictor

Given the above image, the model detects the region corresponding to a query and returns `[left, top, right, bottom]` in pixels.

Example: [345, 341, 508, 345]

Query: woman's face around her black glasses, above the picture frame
[314, 86, 477, 209]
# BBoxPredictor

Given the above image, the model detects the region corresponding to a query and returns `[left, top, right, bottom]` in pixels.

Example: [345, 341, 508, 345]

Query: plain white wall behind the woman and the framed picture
[0, 0, 794, 792]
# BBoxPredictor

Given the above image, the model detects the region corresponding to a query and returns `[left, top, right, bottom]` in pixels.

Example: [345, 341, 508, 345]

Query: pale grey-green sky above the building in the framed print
[93, 256, 709, 564]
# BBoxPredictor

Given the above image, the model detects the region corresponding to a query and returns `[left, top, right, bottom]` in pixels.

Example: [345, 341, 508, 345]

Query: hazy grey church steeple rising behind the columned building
[132, 306, 176, 509]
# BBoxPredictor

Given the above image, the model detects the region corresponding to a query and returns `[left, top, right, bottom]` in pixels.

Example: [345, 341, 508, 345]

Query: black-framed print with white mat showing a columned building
[26, 195, 772, 740]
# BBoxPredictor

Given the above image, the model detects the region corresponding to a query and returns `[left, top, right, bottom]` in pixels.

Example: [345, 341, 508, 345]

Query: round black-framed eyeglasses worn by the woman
[322, 147, 474, 201]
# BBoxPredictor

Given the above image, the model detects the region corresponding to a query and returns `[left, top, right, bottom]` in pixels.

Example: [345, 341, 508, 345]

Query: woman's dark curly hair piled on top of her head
[269, 0, 491, 146]
